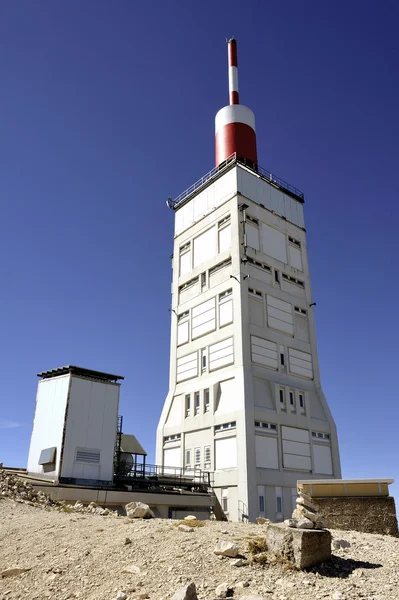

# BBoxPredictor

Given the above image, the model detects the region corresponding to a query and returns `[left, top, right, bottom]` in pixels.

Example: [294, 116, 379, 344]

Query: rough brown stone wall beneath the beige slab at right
[312, 496, 398, 536]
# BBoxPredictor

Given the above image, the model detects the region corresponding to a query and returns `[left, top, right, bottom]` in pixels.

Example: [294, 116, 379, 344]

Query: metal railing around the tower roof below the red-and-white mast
[166, 152, 305, 210]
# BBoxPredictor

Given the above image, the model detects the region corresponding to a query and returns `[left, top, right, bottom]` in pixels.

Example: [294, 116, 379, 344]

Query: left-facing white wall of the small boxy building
[27, 375, 70, 474]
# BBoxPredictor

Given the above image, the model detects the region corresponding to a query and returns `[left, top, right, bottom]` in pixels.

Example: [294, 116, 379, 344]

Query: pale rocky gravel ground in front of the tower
[0, 497, 399, 600]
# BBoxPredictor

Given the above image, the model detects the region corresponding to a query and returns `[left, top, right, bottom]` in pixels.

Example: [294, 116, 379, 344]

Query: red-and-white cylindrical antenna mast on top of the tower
[215, 38, 258, 167]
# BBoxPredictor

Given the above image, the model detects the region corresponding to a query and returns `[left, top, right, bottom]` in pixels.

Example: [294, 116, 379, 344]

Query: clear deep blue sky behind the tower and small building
[0, 0, 399, 502]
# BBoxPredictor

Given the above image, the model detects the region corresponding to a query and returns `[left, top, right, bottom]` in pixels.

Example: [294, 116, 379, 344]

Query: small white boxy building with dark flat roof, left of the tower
[27, 366, 123, 485]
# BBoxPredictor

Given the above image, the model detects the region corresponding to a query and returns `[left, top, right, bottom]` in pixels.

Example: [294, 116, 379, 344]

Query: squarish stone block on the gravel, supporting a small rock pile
[265, 523, 331, 569]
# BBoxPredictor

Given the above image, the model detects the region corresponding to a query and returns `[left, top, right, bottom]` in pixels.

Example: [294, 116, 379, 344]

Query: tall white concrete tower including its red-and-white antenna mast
[156, 39, 341, 521]
